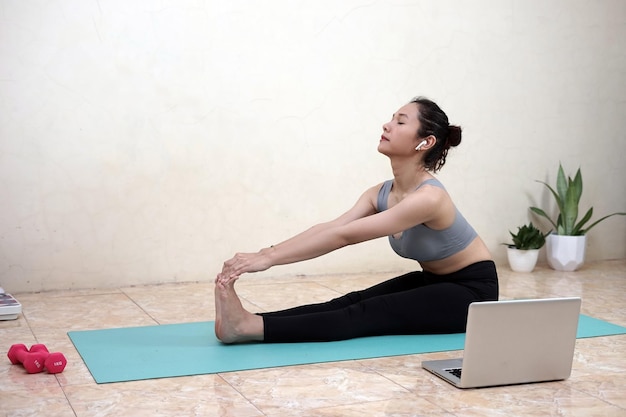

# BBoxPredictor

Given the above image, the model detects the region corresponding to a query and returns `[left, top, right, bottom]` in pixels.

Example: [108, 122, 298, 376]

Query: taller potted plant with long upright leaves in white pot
[530, 163, 626, 271]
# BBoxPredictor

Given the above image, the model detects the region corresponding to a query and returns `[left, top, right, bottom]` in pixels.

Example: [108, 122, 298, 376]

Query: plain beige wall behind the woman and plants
[0, 0, 626, 292]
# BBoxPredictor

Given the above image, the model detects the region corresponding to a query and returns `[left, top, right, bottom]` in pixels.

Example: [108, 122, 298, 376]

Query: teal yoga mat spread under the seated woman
[68, 315, 626, 384]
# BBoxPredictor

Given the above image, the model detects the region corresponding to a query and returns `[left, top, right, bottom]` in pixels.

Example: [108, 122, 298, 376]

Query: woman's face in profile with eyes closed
[378, 103, 420, 156]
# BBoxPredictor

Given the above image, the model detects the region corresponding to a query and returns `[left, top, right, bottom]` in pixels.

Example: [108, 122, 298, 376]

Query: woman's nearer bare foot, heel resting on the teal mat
[215, 281, 263, 343]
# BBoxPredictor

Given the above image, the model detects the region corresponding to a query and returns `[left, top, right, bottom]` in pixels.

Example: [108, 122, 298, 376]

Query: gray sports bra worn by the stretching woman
[377, 178, 477, 262]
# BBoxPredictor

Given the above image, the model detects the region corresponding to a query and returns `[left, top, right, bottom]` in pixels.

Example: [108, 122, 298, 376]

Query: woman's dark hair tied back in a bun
[411, 97, 461, 172]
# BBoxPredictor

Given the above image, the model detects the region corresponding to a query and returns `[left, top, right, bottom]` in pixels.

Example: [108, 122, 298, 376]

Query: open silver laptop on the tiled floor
[422, 297, 581, 388]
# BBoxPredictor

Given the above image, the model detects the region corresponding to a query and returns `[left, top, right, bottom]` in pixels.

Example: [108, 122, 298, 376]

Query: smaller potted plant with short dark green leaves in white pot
[505, 222, 549, 272]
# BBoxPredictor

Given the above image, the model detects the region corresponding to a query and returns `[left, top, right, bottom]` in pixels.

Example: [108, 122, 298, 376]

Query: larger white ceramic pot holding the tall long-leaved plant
[546, 234, 587, 271]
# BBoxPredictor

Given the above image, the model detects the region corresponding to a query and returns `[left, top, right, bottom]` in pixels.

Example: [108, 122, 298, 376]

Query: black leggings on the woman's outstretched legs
[260, 261, 498, 343]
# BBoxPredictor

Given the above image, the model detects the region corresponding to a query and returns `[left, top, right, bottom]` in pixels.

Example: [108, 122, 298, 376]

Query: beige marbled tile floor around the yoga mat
[0, 260, 626, 417]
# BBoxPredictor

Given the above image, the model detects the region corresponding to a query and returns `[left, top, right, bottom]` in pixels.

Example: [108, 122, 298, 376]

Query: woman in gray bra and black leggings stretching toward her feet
[215, 97, 498, 343]
